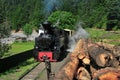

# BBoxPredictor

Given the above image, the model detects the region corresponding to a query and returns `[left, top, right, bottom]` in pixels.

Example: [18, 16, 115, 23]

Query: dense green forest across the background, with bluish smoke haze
[0, 0, 120, 37]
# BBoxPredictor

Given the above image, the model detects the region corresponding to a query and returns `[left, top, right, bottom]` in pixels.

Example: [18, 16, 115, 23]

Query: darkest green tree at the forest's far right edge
[105, 0, 120, 30]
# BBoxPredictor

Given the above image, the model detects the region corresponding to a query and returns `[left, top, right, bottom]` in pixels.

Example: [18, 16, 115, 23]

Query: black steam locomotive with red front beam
[34, 21, 68, 62]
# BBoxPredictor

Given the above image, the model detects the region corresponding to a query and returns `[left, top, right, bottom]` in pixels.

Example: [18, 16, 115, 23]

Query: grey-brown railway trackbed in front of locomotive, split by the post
[19, 52, 68, 80]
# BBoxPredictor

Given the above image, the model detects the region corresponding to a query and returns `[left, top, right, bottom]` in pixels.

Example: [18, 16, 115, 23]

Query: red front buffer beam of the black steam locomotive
[38, 52, 57, 62]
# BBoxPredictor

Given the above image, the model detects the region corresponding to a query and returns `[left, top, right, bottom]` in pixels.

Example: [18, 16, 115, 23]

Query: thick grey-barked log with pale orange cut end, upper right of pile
[88, 46, 113, 67]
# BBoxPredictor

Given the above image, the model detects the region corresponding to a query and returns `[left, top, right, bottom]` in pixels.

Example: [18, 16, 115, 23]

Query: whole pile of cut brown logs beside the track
[54, 39, 120, 80]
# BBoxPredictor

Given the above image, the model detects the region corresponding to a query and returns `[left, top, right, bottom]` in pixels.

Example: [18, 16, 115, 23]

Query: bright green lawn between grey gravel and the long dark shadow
[3, 42, 34, 58]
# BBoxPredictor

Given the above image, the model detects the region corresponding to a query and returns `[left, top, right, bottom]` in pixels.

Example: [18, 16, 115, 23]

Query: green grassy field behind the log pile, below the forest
[86, 28, 120, 45]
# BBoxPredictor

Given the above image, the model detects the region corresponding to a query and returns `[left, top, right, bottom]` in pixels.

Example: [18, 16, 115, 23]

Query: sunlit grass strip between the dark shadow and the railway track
[0, 58, 38, 80]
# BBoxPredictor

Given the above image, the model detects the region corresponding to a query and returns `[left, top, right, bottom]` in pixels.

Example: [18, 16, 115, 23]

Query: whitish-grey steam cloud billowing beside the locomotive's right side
[67, 23, 89, 52]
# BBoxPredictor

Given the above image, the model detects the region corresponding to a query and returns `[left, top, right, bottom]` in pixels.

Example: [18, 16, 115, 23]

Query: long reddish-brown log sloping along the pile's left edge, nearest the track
[54, 39, 84, 80]
